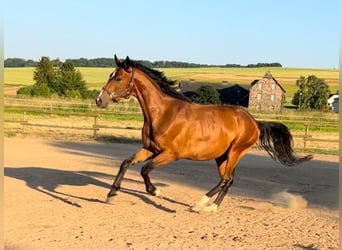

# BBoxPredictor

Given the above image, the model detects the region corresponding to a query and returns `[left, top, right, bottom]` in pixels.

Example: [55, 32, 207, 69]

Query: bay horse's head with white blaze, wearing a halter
[95, 55, 134, 108]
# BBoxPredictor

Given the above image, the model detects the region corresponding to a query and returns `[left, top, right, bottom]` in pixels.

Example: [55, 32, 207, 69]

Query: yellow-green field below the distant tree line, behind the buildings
[4, 68, 339, 100]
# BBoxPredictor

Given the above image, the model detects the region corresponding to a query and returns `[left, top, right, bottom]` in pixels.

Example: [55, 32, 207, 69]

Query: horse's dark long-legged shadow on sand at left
[4, 167, 189, 213]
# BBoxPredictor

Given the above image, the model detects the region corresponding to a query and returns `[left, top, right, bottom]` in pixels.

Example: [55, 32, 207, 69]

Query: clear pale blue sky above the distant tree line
[3, 0, 341, 68]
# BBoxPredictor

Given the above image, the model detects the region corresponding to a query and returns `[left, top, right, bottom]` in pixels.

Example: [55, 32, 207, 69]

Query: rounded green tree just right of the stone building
[292, 75, 330, 110]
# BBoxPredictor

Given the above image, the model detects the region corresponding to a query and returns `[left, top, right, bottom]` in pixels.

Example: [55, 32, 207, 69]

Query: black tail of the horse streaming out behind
[257, 121, 312, 166]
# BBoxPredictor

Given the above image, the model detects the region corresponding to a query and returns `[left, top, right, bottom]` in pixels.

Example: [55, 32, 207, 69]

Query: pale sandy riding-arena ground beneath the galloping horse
[4, 138, 339, 250]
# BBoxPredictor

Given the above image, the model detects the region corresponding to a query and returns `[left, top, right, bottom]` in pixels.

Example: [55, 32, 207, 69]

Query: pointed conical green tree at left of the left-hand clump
[33, 56, 56, 85]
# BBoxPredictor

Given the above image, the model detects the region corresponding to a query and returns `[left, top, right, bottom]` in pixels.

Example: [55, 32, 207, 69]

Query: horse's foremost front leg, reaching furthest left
[107, 148, 153, 202]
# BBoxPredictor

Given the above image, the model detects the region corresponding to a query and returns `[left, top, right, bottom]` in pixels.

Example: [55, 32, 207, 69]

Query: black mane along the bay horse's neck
[125, 60, 191, 102]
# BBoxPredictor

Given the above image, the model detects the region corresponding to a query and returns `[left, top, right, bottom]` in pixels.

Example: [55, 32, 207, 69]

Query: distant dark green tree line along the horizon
[4, 58, 282, 68]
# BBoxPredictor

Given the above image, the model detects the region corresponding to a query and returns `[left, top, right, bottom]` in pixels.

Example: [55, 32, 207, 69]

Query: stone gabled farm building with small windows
[248, 71, 286, 112]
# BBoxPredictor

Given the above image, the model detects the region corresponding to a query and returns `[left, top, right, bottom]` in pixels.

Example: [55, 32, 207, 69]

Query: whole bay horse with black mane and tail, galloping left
[95, 55, 312, 212]
